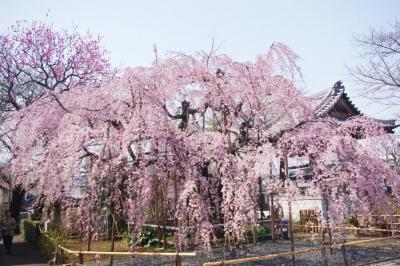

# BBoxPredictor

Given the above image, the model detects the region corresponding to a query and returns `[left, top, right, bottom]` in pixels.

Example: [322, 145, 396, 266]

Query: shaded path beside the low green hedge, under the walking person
[0, 236, 48, 266]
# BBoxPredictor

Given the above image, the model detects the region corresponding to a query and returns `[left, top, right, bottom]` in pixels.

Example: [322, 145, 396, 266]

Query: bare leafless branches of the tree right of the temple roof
[350, 21, 400, 105]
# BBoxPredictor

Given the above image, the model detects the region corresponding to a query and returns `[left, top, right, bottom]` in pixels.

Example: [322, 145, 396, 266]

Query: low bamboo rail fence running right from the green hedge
[43, 233, 196, 266]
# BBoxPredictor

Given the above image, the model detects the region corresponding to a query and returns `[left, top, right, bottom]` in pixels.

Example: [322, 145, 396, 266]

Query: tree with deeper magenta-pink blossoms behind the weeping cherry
[0, 21, 112, 116]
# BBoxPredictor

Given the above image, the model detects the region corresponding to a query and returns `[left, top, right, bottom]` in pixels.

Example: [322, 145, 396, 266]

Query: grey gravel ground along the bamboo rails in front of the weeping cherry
[87, 240, 400, 266]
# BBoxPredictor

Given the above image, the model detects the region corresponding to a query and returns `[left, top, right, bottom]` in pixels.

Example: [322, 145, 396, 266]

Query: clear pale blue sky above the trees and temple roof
[0, 0, 400, 118]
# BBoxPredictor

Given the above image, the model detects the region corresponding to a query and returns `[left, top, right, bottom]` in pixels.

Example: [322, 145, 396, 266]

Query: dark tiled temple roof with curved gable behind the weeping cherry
[309, 81, 399, 133]
